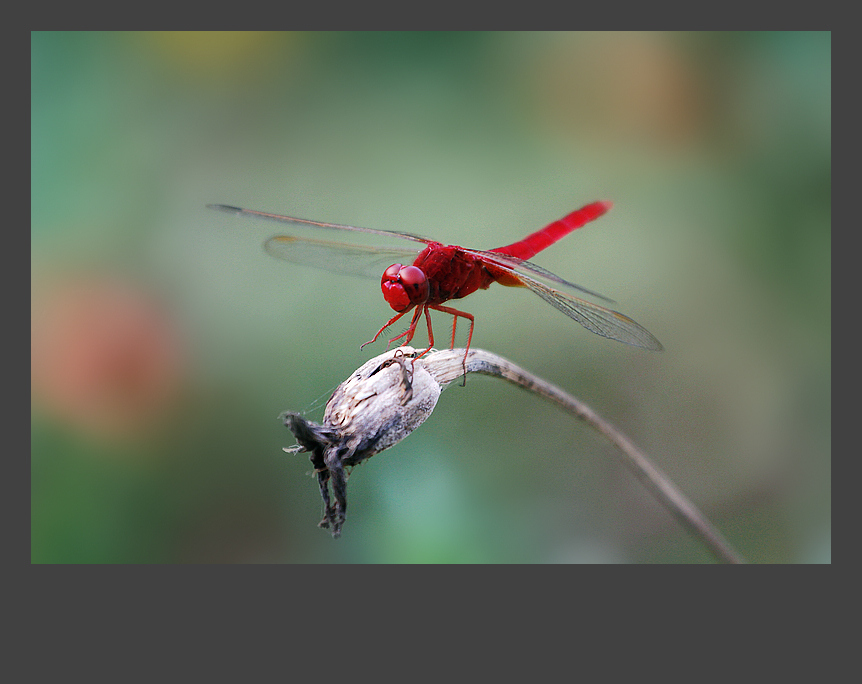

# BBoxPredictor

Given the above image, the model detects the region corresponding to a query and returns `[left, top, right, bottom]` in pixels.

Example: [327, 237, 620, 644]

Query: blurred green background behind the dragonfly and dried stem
[31, 33, 831, 563]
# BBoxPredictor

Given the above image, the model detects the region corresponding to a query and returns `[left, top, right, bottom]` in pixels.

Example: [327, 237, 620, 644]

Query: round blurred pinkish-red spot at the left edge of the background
[30, 277, 182, 438]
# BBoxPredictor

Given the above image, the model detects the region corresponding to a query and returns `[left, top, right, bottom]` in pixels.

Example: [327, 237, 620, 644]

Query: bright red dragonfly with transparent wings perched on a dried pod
[207, 202, 662, 360]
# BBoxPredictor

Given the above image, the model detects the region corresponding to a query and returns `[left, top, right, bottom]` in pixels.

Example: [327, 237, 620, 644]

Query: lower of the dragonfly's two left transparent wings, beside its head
[263, 235, 419, 278]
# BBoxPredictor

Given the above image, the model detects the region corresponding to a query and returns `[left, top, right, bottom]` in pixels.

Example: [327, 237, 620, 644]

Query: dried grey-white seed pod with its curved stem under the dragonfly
[283, 347, 743, 563]
